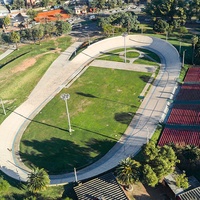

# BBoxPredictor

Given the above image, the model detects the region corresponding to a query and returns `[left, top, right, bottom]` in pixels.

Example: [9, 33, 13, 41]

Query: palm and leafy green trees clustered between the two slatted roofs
[116, 140, 188, 188]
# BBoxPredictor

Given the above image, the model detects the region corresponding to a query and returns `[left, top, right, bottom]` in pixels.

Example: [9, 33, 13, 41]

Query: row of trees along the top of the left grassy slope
[1, 21, 71, 49]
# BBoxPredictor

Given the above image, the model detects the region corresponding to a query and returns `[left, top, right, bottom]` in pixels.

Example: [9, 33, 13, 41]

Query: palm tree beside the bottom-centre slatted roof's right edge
[116, 157, 141, 189]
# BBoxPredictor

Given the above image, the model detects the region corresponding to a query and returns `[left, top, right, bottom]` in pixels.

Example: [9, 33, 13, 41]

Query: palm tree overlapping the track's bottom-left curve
[27, 167, 50, 193]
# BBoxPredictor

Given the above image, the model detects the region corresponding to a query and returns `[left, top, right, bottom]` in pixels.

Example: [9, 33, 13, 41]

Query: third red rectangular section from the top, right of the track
[167, 104, 200, 126]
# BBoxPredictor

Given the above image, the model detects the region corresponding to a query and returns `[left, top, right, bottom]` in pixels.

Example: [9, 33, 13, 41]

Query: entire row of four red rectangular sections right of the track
[158, 67, 200, 147]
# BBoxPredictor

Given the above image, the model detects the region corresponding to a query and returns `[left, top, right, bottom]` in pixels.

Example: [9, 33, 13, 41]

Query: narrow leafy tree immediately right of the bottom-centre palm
[143, 164, 159, 187]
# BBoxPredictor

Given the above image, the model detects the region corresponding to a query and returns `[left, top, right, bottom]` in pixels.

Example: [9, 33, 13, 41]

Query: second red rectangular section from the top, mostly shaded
[176, 84, 200, 101]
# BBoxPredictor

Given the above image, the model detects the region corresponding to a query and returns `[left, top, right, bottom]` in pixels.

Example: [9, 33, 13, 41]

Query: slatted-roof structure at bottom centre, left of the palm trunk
[74, 173, 128, 200]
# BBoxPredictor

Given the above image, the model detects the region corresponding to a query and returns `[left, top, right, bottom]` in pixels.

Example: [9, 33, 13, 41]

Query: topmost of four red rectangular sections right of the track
[184, 67, 200, 82]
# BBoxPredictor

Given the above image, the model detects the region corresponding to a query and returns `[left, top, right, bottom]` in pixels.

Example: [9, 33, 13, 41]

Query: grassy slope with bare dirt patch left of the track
[0, 37, 71, 123]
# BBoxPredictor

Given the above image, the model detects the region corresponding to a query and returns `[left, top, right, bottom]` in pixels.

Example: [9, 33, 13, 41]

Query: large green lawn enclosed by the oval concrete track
[20, 67, 151, 174]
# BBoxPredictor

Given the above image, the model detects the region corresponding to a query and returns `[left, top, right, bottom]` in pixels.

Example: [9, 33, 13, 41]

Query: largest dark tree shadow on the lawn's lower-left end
[20, 136, 91, 174]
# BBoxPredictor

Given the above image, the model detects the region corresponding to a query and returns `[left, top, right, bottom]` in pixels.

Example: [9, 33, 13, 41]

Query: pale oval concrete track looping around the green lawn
[0, 35, 181, 184]
